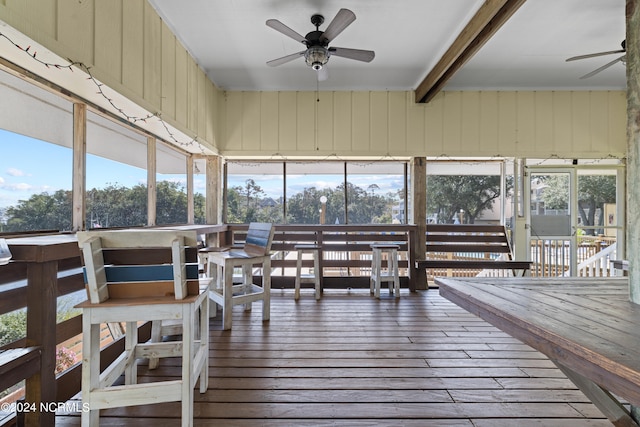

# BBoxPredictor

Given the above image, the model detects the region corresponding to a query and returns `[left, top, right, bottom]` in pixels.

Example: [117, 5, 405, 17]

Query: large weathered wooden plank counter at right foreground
[436, 277, 640, 426]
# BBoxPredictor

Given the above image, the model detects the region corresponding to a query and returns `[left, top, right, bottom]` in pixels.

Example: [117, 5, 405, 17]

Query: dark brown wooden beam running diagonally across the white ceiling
[415, 0, 525, 102]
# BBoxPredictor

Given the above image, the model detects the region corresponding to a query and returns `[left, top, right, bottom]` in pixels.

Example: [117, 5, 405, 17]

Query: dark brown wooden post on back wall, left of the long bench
[409, 157, 427, 289]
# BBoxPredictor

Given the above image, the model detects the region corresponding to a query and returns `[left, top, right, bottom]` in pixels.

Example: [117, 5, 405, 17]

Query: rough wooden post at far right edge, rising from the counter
[626, 0, 640, 304]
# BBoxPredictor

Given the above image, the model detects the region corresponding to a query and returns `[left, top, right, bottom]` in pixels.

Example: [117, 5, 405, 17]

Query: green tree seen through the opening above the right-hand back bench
[427, 175, 500, 224]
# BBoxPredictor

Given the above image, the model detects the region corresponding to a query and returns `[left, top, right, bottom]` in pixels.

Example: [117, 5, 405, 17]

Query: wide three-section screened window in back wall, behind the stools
[224, 161, 407, 224]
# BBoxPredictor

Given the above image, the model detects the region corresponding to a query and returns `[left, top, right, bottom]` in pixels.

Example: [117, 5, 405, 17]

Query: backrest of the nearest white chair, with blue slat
[77, 230, 199, 304]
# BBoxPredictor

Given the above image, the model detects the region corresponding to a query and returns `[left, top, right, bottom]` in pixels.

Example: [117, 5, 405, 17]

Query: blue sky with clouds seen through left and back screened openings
[0, 129, 403, 209]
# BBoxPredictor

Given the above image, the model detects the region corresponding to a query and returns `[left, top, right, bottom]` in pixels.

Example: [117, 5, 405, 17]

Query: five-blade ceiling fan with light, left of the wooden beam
[267, 9, 375, 80]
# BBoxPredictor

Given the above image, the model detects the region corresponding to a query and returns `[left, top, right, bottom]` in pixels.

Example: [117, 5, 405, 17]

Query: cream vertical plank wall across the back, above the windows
[218, 91, 626, 158]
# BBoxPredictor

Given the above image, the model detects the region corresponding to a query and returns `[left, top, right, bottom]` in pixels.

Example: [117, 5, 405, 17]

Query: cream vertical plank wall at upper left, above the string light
[0, 0, 223, 149]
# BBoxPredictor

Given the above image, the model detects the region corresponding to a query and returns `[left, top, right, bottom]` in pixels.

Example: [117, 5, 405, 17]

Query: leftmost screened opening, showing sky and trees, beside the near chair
[0, 71, 73, 232]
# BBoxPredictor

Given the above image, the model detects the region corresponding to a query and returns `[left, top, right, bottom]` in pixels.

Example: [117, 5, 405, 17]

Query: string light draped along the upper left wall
[0, 32, 205, 154]
